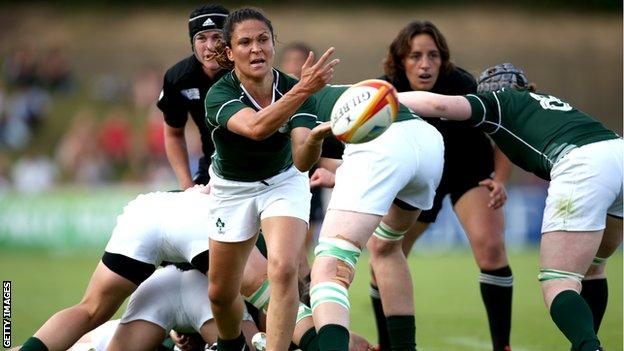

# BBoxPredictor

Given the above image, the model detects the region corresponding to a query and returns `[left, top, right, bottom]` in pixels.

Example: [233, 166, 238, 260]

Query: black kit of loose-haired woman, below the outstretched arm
[418, 124, 494, 223]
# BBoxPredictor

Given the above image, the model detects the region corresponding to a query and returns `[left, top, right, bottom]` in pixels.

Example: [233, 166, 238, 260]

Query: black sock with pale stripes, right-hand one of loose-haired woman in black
[479, 266, 513, 351]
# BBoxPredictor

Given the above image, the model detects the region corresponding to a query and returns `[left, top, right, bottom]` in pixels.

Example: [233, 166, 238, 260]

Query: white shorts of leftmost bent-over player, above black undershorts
[105, 192, 210, 266]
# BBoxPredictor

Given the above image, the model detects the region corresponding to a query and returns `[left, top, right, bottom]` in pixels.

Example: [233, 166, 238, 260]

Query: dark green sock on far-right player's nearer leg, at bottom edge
[550, 290, 600, 351]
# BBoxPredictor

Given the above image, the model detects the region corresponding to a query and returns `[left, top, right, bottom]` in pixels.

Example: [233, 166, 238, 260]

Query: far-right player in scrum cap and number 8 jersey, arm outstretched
[399, 63, 624, 351]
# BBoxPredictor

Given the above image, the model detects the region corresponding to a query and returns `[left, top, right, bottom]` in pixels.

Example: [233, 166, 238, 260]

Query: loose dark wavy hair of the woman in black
[383, 21, 454, 81]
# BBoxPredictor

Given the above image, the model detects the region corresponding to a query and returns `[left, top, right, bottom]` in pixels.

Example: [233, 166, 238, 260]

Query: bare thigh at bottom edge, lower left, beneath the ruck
[107, 320, 167, 351]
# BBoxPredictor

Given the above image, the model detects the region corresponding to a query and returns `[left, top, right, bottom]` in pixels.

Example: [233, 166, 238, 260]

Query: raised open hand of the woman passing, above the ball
[297, 47, 340, 94]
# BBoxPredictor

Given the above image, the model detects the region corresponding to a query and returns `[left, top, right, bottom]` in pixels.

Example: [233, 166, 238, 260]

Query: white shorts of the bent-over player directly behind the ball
[328, 119, 444, 216]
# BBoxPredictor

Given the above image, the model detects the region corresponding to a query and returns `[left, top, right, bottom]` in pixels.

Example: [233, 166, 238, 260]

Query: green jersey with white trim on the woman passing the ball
[205, 69, 316, 182]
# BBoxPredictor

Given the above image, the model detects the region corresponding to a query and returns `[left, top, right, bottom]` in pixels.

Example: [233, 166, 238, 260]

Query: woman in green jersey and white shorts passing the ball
[205, 8, 338, 351]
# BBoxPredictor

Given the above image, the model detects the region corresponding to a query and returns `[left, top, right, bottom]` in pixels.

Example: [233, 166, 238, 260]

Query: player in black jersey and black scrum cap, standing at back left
[157, 4, 229, 189]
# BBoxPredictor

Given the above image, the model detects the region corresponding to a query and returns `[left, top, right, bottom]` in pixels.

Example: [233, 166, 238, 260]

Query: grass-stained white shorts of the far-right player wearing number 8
[542, 139, 624, 233]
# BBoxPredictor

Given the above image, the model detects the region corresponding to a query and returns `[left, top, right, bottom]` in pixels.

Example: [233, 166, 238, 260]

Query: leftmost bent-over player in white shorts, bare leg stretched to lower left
[21, 186, 214, 351]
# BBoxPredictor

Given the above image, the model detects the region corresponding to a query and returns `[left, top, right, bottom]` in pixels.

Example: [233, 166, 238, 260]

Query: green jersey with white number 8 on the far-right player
[466, 89, 619, 180]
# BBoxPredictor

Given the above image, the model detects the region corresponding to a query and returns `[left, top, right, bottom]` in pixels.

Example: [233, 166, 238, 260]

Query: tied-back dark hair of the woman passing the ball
[215, 7, 275, 69]
